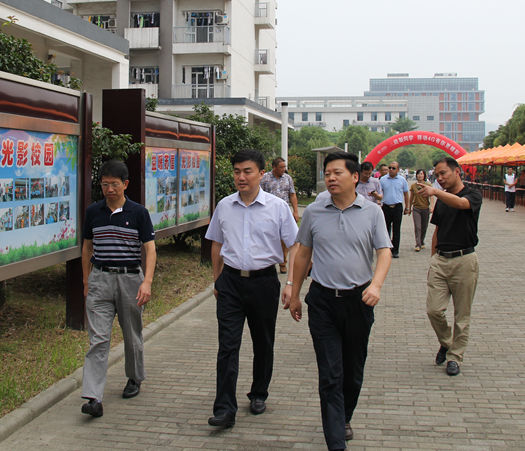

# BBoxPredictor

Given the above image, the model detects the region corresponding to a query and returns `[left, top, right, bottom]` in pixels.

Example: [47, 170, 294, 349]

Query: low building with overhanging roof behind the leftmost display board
[0, 0, 129, 121]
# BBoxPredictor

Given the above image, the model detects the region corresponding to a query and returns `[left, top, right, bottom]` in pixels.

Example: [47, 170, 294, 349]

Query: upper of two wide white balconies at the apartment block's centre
[173, 25, 231, 55]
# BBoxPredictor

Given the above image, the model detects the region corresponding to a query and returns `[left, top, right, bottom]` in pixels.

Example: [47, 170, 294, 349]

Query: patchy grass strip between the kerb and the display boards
[0, 238, 213, 417]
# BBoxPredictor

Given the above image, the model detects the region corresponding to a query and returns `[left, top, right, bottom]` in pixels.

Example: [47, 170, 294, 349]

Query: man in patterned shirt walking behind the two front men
[261, 157, 299, 274]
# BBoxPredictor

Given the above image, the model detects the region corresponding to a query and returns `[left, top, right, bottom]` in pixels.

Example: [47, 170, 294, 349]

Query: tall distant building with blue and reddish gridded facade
[364, 73, 485, 151]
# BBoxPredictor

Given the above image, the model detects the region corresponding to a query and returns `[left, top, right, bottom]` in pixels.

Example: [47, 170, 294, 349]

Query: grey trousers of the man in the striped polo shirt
[82, 268, 145, 401]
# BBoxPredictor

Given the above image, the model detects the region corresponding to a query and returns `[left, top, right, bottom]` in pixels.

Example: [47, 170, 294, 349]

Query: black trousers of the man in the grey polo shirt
[306, 282, 374, 450]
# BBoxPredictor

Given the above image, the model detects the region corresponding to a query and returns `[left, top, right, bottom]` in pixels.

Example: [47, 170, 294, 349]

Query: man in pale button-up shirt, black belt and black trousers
[206, 150, 298, 427]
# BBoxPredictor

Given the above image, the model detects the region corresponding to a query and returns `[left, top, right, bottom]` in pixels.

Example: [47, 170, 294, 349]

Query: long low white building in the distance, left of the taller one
[277, 96, 408, 132]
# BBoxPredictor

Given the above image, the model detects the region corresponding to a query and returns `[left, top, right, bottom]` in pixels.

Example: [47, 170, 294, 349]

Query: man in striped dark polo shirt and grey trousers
[82, 160, 157, 417]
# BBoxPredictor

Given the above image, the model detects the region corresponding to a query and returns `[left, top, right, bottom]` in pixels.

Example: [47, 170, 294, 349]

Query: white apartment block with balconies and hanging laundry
[68, 0, 280, 131]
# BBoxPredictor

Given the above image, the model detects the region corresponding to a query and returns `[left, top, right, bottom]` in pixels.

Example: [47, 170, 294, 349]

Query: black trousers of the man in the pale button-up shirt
[213, 271, 281, 415]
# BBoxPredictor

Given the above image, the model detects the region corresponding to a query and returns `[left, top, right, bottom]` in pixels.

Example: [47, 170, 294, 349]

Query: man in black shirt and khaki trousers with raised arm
[418, 157, 482, 376]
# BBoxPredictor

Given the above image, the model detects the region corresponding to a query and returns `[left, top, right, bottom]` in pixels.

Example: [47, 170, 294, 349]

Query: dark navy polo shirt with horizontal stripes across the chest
[84, 198, 155, 266]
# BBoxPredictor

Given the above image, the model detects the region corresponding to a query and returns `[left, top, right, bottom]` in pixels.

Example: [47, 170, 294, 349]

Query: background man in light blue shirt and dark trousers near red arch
[379, 161, 410, 258]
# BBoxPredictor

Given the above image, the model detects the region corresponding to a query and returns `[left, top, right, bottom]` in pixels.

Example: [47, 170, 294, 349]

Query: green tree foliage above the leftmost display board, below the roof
[0, 16, 82, 89]
